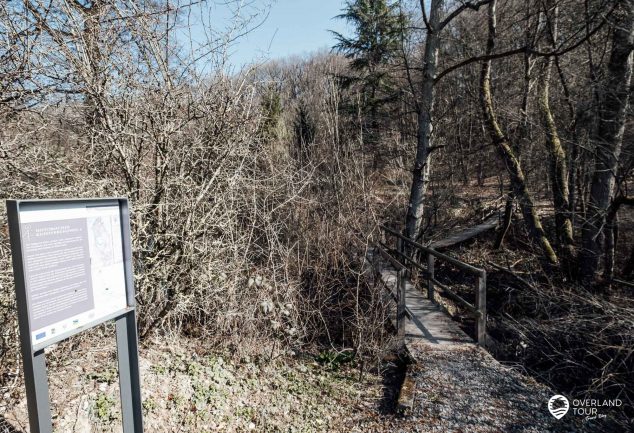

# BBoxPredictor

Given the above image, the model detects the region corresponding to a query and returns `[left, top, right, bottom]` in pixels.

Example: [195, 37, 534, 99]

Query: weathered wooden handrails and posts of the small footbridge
[379, 226, 487, 346]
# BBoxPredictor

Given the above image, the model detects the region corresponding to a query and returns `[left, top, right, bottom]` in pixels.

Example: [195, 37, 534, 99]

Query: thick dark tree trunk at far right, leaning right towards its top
[579, 0, 634, 283]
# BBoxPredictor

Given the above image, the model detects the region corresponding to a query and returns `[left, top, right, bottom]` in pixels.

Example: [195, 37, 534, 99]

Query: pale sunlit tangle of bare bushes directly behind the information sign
[0, 2, 299, 388]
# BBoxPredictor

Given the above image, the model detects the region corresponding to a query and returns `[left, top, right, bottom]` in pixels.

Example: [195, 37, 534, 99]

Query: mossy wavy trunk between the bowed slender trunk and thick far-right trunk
[538, 0, 574, 250]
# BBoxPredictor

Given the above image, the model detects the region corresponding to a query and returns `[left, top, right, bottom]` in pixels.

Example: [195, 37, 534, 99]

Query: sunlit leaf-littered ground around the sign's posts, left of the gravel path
[0, 338, 385, 433]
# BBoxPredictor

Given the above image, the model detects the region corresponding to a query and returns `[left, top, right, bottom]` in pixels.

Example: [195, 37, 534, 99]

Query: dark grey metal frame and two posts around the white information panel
[6, 197, 143, 433]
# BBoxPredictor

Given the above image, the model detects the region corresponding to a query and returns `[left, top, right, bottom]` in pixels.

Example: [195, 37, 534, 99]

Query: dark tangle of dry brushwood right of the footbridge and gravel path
[498, 285, 634, 428]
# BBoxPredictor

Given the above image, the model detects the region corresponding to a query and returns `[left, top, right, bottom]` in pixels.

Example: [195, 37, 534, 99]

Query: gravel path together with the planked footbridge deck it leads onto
[367, 249, 601, 433]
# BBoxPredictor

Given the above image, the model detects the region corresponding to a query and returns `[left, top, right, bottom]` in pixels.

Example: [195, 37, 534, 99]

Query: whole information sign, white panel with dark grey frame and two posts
[7, 198, 143, 433]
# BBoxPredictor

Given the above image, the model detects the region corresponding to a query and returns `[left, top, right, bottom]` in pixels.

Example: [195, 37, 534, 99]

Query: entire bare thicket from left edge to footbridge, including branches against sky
[0, 0, 385, 379]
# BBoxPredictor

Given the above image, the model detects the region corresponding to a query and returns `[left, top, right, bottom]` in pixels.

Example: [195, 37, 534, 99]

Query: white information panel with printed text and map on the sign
[13, 201, 128, 346]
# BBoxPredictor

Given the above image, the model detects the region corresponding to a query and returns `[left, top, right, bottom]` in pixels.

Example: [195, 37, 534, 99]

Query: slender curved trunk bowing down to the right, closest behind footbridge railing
[480, 0, 558, 264]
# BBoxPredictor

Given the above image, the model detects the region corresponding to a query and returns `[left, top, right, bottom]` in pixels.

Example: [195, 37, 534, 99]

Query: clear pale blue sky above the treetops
[183, 0, 350, 66]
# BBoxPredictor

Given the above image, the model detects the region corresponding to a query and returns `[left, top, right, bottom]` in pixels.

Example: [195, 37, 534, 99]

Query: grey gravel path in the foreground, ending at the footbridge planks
[392, 344, 612, 433]
